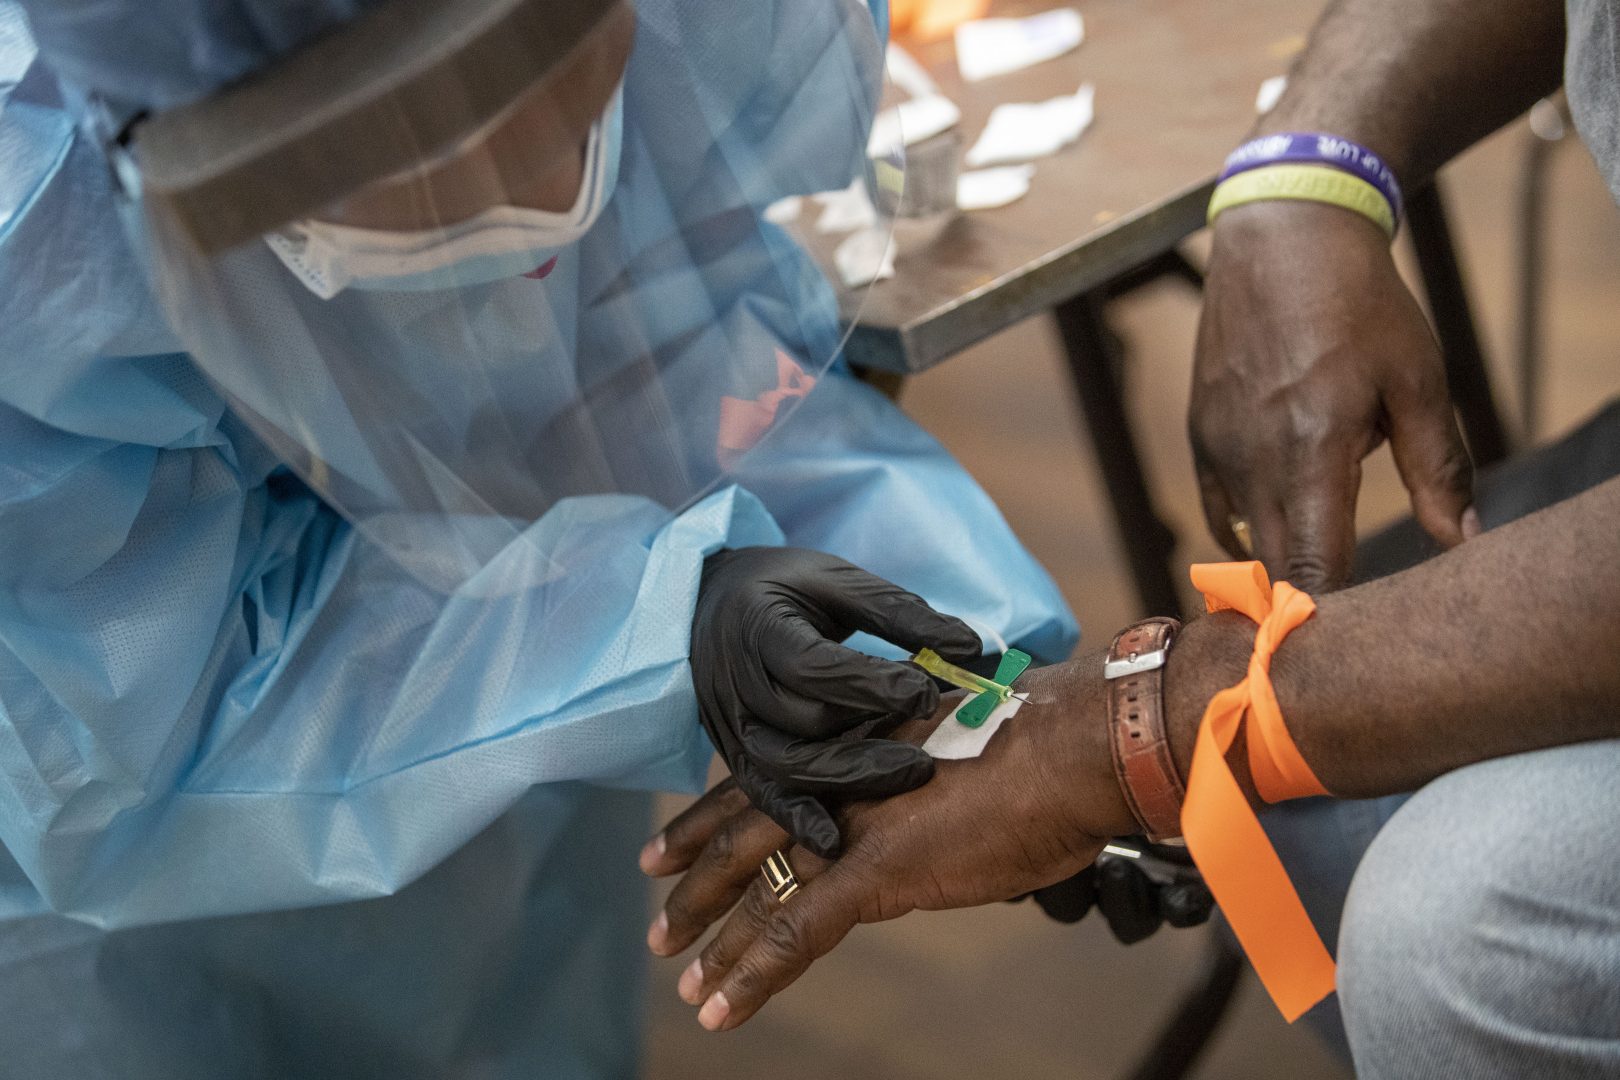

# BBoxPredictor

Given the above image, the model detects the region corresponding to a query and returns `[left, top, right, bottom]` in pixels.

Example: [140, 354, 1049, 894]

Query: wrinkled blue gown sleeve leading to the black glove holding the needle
[0, 406, 781, 926]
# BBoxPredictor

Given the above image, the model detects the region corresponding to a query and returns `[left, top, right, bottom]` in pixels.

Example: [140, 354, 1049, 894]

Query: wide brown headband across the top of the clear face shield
[115, 0, 625, 254]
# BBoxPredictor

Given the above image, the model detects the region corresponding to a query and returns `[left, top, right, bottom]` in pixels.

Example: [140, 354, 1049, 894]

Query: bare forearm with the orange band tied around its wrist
[1166, 479, 1620, 797]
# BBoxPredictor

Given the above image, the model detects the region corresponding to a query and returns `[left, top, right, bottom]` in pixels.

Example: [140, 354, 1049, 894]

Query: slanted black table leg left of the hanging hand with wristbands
[1053, 291, 1181, 615]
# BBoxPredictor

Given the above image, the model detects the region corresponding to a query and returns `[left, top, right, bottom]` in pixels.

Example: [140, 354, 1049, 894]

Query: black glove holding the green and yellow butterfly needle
[692, 547, 982, 858]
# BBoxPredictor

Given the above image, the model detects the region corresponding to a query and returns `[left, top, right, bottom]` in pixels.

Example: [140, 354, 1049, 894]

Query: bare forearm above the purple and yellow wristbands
[1259, 0, 1563, 185]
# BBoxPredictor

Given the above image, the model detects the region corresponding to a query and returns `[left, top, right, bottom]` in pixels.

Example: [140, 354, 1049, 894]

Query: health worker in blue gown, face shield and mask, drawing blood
[0, 0, 1077, 1080]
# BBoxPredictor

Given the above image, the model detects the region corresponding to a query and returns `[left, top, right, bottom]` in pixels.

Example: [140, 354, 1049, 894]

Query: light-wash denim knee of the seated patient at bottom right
[1338, 744, 1620, 1080]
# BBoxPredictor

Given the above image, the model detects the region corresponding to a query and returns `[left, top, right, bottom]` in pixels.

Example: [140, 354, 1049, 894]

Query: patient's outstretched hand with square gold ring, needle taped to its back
[642, 656, 1137, 1030]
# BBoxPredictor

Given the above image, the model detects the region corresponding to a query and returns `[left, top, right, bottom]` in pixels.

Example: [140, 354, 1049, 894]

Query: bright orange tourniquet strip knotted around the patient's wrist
[1181, 562, 1333, 1022]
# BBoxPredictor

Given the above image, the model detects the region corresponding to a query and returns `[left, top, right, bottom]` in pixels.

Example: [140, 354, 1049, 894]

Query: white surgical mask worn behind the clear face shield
[264, 86, 624, 300]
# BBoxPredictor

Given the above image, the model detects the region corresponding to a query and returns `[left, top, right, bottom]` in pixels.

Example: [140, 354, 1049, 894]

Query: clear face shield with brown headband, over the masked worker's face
[115, 0, 899, 593]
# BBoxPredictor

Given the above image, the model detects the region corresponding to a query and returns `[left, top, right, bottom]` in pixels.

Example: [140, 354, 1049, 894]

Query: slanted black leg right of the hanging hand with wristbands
[1406, 183, 1510, 468]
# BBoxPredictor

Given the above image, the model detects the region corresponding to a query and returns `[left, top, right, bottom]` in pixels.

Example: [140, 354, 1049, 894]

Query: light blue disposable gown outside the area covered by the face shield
[0, 0, 1077, 1080]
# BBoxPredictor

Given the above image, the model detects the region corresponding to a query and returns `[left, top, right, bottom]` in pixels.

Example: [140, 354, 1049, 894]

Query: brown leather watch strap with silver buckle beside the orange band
[1103, 619, 1186, 840]
